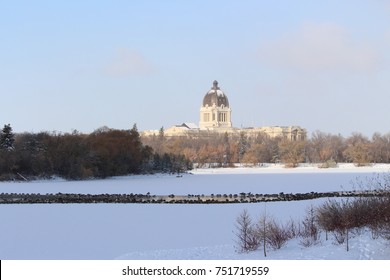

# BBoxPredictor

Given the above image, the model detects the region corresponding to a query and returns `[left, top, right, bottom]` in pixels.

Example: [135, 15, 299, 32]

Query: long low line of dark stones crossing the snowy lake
[0, 190, 390, 204]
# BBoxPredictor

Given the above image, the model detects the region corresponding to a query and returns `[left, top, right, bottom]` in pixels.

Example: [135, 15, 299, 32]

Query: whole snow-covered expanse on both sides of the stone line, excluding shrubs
[0, 165, 390, 259]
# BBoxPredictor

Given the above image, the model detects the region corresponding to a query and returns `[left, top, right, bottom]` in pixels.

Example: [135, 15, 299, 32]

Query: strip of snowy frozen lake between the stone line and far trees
[0, 164, 390, 195]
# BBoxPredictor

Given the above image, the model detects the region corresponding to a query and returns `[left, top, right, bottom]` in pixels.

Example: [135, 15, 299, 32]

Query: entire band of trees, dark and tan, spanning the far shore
[0, 124, 390, 180]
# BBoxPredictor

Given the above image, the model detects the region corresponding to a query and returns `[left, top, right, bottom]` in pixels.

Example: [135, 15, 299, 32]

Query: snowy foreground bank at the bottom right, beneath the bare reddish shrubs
[117, 232, 390, 260]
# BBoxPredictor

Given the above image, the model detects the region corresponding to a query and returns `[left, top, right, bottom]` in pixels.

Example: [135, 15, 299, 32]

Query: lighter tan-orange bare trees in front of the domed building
[143, 129, 390, 168]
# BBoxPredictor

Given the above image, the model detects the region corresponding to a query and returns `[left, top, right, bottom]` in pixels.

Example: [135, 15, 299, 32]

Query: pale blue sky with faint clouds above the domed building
[0, 0, 390, 137]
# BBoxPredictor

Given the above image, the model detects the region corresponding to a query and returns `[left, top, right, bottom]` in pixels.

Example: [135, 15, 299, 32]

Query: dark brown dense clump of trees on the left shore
[0, 125, 191, 180]
